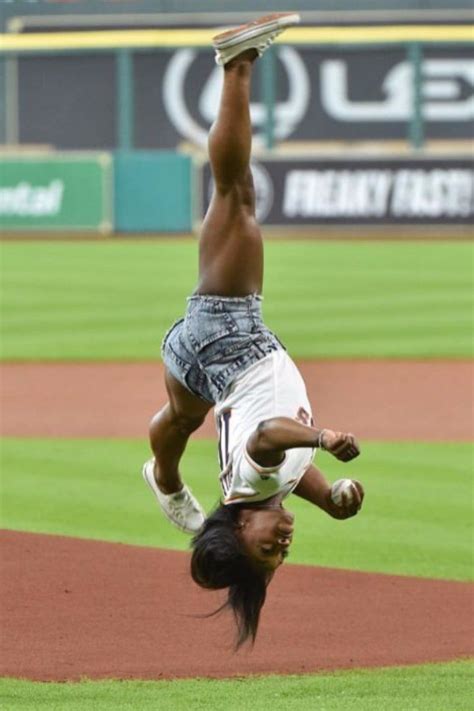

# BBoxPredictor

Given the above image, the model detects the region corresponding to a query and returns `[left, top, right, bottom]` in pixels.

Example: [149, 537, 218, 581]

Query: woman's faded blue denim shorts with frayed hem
[161, 294, 284, 405]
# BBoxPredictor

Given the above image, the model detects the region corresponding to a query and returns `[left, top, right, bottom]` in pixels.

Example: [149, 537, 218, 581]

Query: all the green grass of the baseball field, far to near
[0, 240, 473, 711]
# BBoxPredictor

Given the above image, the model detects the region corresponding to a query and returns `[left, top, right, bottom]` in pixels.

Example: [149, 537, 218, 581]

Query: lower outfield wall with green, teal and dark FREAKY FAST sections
[0, 151, 474, 233]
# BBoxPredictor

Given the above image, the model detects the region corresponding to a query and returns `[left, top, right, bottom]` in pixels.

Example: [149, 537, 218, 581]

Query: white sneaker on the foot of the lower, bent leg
[142, 459, 206, 534]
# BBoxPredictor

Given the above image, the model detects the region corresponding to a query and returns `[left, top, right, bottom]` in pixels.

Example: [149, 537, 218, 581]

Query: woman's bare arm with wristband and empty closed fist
[247, 417, 360, 467]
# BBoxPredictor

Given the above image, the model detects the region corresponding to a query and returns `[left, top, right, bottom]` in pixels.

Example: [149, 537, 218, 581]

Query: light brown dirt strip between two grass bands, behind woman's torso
[0, 360, 474, 441]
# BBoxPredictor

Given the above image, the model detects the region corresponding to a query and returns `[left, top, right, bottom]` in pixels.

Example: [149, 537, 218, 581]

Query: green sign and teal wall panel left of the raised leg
[0, 151, 194, 233]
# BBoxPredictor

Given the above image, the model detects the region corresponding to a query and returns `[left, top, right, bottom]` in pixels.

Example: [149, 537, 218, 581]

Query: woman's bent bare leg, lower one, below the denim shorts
[150, 373, 211, 494]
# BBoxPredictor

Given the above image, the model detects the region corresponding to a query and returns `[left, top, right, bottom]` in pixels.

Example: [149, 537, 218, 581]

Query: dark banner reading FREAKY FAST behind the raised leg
[202, 157, 474, 227]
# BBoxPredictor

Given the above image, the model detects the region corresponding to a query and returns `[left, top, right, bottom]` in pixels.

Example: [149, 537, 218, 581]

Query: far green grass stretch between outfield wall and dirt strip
[1, 239, 473, 360]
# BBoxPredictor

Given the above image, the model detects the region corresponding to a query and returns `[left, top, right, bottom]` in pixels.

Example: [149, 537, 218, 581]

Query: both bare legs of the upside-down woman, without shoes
[150, 50, 263, 494]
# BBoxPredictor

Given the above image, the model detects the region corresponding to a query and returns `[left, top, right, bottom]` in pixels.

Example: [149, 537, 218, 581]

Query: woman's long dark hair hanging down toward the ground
[191, 504, 271, 649]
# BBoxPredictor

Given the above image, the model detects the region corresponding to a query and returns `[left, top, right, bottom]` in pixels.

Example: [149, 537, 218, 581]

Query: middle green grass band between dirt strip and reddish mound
[1, 438, 473, 580]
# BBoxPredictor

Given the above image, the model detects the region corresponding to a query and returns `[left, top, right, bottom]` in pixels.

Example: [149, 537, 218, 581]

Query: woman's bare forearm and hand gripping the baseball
[293, 464, 364, 519]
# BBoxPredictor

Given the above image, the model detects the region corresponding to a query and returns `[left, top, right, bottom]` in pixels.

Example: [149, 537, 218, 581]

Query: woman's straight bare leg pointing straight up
[197, 50, 263, 296]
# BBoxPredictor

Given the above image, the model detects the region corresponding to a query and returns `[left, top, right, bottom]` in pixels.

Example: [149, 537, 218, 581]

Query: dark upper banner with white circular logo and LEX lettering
[17, 45, 474, 150]
